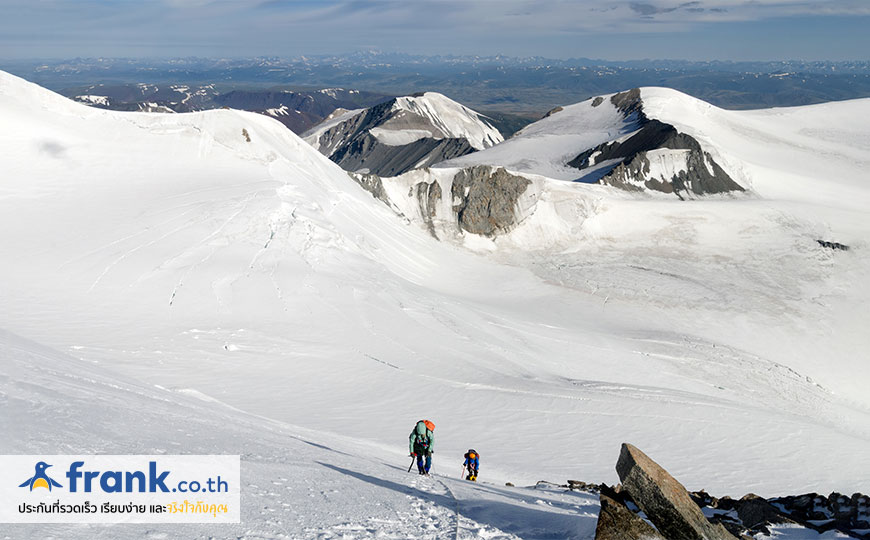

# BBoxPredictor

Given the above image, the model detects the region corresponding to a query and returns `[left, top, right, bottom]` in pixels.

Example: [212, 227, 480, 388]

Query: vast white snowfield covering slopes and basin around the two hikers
[0, 72, 870, 538]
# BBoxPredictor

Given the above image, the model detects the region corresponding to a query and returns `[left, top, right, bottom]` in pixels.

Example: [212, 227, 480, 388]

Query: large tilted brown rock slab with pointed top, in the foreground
[616, 444, 736, 540]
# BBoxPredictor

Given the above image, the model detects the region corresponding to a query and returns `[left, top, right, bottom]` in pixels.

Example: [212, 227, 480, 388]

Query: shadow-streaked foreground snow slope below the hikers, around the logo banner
[0, 331, 598, 540]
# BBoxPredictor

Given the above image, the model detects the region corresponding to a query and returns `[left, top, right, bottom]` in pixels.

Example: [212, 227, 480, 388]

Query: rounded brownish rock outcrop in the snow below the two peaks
[452, 166, 531, 236]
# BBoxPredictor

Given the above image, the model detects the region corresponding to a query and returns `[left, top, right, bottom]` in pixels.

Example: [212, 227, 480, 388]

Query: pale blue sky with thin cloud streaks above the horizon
[0, 0, 870, 60]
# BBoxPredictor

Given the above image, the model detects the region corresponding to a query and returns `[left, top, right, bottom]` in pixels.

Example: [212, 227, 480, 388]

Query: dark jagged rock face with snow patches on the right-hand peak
[568, 89, 744, 199]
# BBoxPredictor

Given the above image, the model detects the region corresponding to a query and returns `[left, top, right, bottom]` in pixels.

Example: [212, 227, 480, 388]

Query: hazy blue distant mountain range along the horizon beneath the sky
[6, 52, 870, 119]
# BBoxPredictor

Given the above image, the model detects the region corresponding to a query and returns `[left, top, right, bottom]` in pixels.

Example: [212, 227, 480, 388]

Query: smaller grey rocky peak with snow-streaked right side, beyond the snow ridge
[303, 92, 503, 176]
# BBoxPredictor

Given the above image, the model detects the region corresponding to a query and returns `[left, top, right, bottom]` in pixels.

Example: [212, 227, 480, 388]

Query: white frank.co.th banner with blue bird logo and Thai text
[0, 455, 241, 523]
